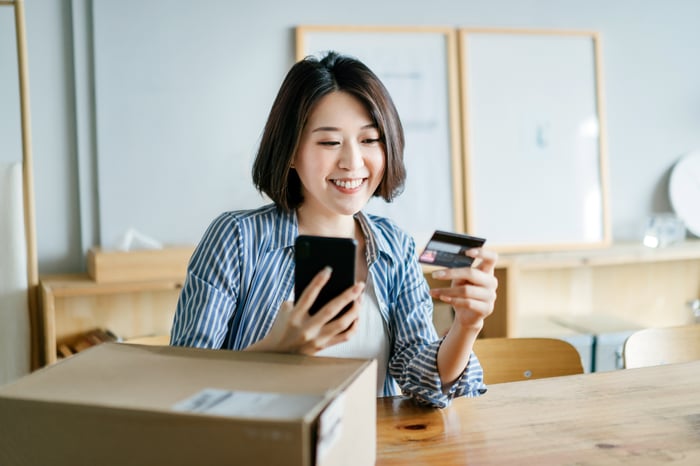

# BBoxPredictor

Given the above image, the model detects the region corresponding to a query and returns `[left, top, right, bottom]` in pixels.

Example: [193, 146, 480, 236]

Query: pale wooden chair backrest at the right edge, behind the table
[622, 324, 700, 368]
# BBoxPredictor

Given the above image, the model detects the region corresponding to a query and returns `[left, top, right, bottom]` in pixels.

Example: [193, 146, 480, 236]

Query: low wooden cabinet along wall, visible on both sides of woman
[40, 240, 700, 364]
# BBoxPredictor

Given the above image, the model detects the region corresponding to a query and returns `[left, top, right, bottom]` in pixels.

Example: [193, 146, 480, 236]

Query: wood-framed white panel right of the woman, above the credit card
[458, 29, 610, 252]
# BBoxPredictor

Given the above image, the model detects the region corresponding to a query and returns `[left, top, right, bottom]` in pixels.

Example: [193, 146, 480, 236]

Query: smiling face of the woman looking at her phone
[294, 91, 386, 217]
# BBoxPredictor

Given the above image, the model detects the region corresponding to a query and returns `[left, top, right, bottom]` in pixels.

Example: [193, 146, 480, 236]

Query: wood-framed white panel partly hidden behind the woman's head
[296, 26, 464, 247]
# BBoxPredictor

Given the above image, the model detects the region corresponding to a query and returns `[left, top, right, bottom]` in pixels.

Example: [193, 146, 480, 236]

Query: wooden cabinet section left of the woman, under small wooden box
[39, 275, 182, 365]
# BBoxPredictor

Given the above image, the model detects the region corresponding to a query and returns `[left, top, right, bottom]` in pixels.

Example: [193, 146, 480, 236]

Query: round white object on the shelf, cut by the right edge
[668, 151, 700, 236]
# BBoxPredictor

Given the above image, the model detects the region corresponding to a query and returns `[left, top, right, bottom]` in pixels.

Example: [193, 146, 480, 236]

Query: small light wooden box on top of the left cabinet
[87, 246, 194, 283]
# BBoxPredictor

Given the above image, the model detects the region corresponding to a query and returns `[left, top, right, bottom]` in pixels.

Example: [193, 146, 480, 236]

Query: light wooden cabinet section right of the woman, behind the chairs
[483, 240, 700, 337]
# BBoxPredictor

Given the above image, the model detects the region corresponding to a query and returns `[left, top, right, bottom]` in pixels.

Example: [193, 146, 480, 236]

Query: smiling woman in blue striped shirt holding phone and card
[171, 52, 497, 407]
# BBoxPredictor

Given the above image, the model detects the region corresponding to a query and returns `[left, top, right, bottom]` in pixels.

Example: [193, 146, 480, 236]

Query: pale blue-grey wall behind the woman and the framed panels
[0, 0, 700, 274]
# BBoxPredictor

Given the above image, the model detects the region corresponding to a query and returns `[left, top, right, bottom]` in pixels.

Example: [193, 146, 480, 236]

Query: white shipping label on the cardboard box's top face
[172, 388, 323, 419]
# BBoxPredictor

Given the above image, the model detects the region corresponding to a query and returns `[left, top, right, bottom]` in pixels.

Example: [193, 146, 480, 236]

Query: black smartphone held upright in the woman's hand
[294, 235, 357, 319]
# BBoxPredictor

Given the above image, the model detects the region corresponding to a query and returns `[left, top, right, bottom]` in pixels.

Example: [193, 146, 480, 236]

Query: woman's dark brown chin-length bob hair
[253, 51, 406, 211]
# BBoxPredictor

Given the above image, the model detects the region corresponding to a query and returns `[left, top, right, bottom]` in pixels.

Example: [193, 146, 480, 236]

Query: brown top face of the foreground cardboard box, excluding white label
[0, 343, 371, 418]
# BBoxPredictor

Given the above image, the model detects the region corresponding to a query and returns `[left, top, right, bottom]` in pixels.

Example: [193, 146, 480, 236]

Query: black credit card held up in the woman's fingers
[418, 230, 486, 268]
